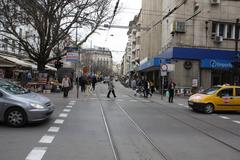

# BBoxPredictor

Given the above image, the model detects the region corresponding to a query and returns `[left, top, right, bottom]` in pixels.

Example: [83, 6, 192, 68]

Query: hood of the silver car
[11, 92, 50, 104]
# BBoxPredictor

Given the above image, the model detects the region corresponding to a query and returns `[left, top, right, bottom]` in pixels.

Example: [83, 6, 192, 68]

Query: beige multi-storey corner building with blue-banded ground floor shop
[140, 0, 240, 92]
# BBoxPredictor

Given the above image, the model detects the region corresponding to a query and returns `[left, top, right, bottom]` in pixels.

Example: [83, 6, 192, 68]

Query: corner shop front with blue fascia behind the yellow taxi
[159, 48, 237, 90]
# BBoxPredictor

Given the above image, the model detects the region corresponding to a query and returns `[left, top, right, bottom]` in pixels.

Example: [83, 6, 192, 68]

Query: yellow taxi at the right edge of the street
[188, 85, 240, 113]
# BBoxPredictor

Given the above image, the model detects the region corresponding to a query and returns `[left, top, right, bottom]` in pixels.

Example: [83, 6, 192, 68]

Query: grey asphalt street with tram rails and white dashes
[0, 82, 240, 160]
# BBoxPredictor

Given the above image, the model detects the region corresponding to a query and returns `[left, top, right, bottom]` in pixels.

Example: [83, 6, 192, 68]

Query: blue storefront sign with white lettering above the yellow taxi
[201, 59, 233, 69]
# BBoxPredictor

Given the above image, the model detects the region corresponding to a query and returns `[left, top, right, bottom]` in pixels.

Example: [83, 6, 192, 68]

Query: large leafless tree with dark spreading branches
[0, 0, 119, 71]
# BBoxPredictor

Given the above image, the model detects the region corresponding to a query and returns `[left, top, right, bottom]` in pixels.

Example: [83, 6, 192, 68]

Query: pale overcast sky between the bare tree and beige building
[85, 0, 142, 63]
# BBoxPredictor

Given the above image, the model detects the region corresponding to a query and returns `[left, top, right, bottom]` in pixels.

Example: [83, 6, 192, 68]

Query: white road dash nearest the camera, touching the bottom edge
[25, 147, 47, 160]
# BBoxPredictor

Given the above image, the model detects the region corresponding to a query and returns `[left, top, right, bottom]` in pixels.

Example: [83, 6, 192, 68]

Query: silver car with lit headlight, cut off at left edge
[0, 79, 54, 127]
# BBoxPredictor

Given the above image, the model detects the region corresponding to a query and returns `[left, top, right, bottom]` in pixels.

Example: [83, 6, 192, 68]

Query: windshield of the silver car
[0, 83, 30, 94]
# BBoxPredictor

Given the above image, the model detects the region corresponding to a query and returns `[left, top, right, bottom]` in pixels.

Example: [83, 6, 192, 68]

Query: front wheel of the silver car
[5, 108, 27, 127]
